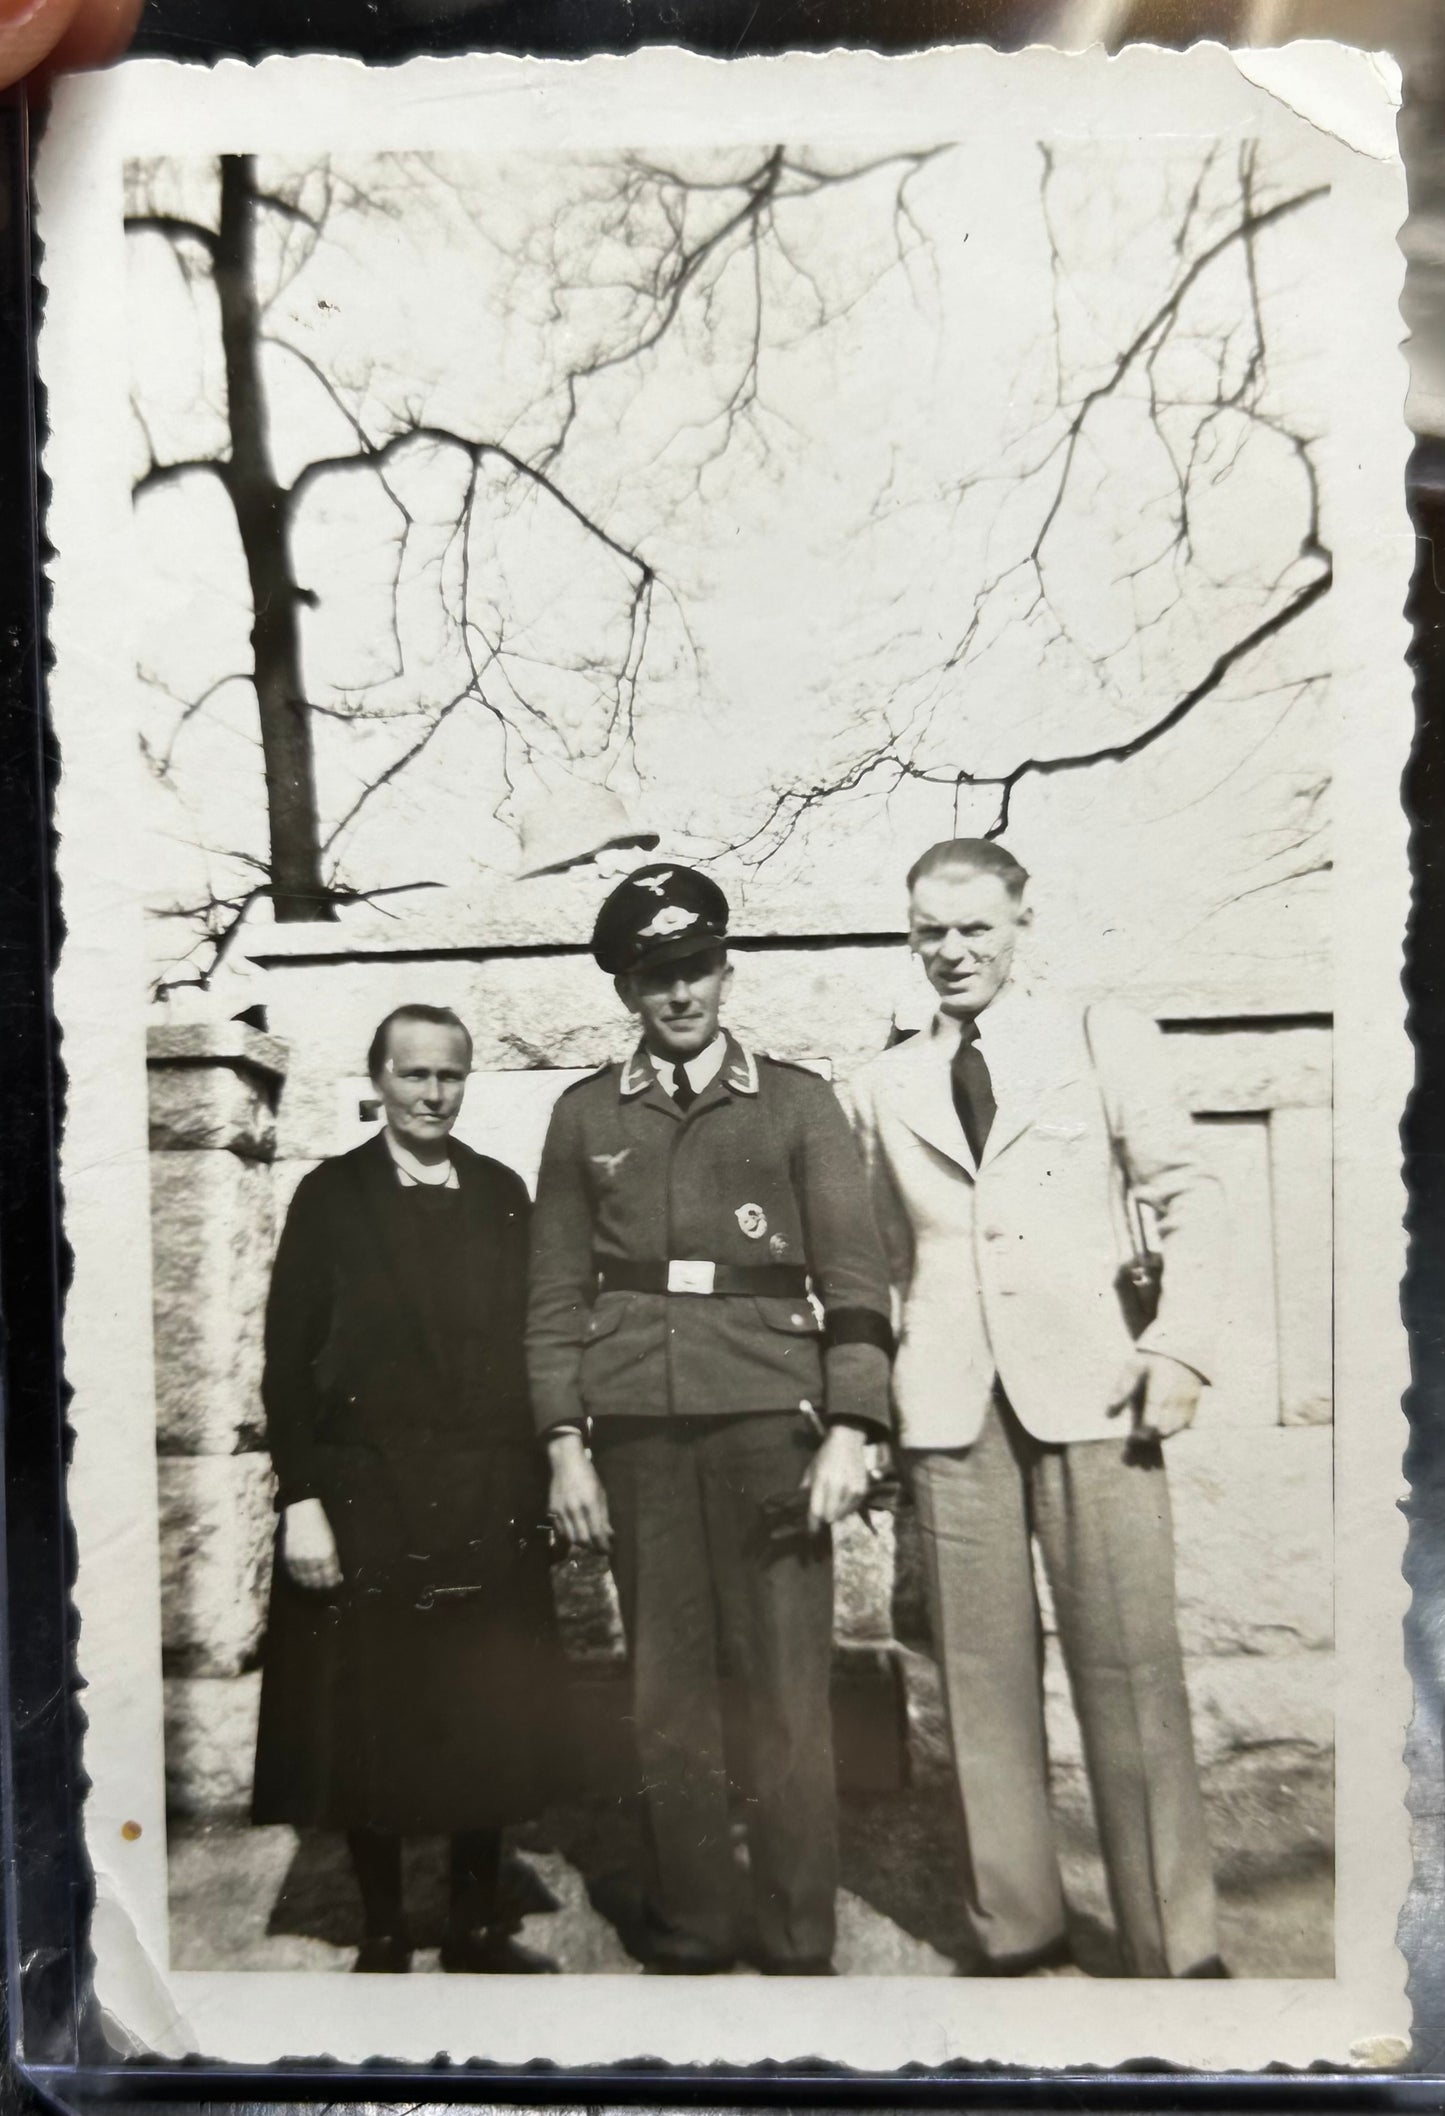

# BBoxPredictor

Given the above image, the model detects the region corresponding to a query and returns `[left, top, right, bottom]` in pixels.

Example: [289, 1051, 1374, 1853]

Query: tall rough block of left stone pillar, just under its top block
[150, 1153, 273, 1454]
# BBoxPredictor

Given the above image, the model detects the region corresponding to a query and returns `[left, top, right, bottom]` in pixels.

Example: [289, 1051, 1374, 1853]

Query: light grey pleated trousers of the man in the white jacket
[910, 1390, 1219, 1976]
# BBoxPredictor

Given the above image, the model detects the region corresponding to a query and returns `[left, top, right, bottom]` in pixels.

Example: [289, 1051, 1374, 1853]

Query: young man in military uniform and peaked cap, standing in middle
[527, 863, 891, 1974]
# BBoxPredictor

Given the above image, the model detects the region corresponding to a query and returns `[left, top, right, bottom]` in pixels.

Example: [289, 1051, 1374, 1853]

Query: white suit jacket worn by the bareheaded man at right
[844, 986, 1223, 1447]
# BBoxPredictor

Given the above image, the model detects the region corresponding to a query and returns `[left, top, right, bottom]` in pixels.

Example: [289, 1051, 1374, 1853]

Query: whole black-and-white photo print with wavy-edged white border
[36, 44, 1413, 2072]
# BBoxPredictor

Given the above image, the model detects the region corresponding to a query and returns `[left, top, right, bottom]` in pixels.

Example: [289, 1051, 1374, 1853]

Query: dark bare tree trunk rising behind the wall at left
[216, 142, 336, 925]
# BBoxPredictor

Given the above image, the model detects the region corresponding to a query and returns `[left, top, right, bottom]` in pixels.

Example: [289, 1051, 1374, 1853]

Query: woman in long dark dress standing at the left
[252, 1007, 563, 1972]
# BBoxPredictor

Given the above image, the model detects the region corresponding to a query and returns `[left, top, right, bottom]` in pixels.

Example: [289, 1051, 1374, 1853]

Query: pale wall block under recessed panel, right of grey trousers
[1168, 1422, 1335, 1655]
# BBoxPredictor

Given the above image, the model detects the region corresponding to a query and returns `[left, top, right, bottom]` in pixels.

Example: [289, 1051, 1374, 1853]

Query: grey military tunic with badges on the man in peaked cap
[527, 1037, 889, 1433]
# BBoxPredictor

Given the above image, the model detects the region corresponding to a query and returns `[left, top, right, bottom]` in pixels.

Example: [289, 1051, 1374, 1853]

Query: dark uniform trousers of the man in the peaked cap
[592, 1411, 838, 1968]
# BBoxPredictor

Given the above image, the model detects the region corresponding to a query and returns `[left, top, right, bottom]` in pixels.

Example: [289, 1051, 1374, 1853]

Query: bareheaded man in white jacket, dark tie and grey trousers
[848, 838, 1225, 1976]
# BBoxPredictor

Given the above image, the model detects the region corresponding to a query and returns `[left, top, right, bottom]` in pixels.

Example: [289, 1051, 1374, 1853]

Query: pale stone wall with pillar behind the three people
[152, 929, 1333, 1887]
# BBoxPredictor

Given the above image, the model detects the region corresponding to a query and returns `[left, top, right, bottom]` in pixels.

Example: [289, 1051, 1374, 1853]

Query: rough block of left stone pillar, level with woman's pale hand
[159, 1454, 275, 1676]
